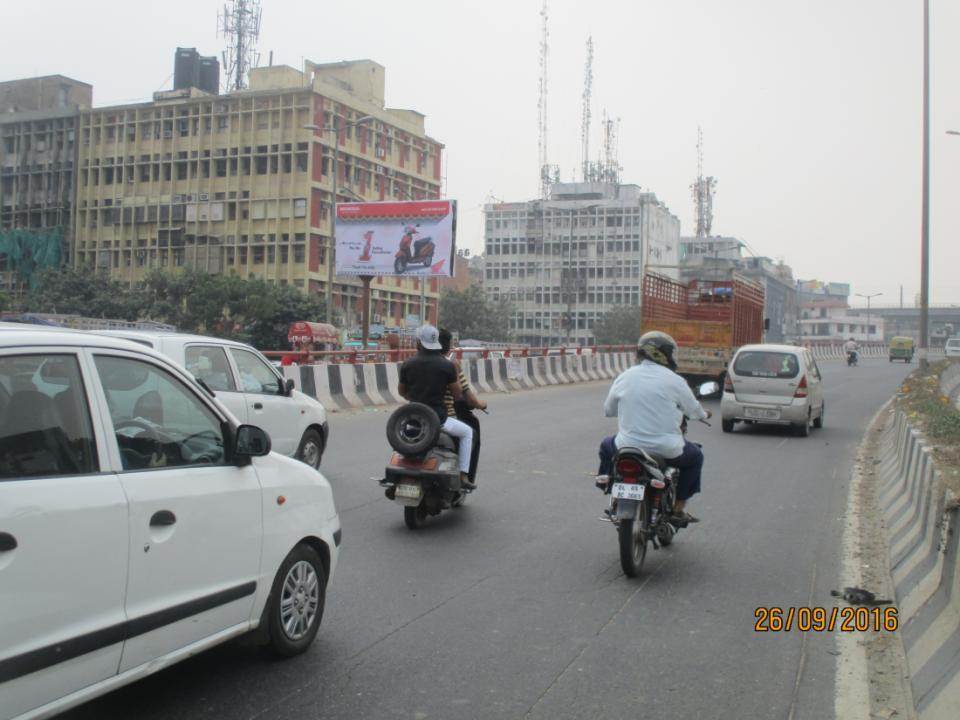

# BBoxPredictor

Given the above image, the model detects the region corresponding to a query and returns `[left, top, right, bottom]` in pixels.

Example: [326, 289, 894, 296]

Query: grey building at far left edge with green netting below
[0, 75, 93, 295]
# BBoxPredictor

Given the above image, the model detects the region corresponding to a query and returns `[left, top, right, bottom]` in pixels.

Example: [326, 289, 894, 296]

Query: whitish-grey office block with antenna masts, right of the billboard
[484, 183, 680, 345]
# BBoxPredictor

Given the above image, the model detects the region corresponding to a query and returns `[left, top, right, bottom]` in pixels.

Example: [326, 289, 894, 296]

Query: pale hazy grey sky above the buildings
[0, 0, 960, 304]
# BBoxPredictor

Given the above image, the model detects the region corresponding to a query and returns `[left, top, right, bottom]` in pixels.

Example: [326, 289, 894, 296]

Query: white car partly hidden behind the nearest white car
[95, 330, 330, 468]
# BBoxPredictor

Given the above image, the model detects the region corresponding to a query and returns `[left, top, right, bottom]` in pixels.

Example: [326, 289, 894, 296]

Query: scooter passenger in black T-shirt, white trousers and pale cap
[398, 325, 474, 489]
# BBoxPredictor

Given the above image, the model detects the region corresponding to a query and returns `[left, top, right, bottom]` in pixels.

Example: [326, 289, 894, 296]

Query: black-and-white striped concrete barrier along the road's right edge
[879, 410, 960, 720]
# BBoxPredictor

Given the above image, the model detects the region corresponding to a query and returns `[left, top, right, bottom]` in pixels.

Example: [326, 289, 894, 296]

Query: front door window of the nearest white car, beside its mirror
[96, 355, 225, 470]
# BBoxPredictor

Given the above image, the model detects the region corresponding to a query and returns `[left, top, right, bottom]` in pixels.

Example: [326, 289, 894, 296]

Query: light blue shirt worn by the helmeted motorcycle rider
[603, 360, 707, 458]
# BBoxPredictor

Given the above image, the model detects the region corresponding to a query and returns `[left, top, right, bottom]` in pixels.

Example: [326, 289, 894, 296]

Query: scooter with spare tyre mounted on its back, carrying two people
[379, 403, 471, 530]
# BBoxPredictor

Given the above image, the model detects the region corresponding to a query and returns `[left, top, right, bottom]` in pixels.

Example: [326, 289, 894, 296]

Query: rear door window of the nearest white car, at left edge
[0, 354, 99, 480]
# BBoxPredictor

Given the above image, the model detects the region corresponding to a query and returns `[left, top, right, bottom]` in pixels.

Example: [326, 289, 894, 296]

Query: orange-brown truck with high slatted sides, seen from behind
[640, 271, 764, 385]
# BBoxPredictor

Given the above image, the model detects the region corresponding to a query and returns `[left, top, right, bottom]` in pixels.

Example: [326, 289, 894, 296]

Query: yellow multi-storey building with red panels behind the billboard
[72, 60, 443, 326]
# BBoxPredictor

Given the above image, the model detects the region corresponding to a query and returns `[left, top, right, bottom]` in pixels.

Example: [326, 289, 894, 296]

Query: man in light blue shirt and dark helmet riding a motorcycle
[597, 331, 712, 523]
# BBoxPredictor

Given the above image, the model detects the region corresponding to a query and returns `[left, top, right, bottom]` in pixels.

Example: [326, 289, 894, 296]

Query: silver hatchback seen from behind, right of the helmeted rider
[720, 345, 824, 436]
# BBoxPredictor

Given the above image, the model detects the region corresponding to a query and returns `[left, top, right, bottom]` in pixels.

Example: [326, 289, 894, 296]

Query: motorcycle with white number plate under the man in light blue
[604, 382, 720, 577]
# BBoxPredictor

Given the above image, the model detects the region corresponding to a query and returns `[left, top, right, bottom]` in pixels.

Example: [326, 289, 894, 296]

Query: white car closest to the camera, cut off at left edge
[0, 323, 341, 720]
